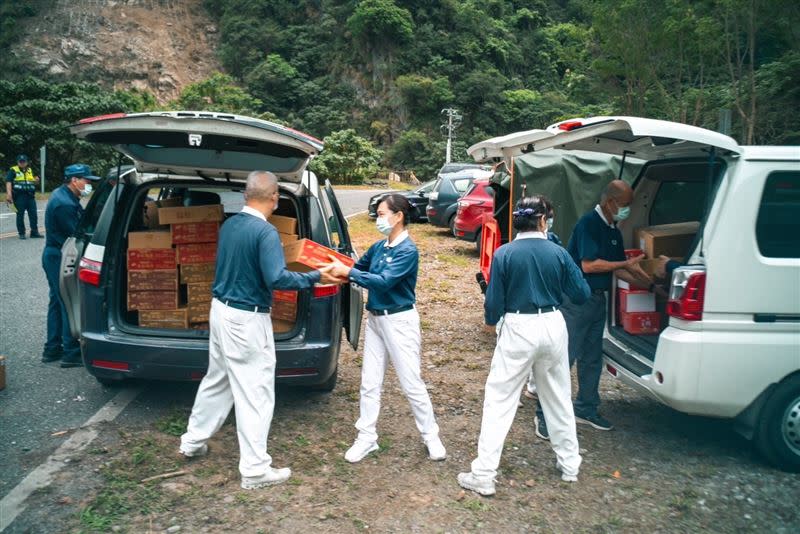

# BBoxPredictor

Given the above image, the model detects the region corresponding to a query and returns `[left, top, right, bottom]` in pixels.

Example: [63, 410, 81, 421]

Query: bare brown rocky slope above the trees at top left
[10, 0, 220, 102]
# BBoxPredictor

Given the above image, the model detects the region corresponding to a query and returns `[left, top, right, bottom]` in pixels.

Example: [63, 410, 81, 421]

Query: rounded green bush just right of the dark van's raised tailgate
[310, 129, 383, 184]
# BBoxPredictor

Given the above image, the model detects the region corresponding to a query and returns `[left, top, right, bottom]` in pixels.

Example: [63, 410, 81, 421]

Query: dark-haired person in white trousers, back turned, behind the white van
[458, 196, 589, 495]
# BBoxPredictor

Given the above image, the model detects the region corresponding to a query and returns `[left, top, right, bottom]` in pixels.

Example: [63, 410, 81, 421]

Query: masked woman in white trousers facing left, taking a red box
[333, 194, 447, 463]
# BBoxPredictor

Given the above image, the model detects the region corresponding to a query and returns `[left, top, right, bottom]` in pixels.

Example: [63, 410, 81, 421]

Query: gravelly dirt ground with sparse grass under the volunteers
[16, 216, 800, 533]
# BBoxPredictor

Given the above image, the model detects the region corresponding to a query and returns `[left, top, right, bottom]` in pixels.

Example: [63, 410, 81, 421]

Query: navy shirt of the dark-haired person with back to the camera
[484, 234, 590, 325]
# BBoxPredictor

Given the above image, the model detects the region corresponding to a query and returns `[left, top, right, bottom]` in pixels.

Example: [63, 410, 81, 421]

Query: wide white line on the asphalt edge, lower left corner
[0, 387, 144, 532]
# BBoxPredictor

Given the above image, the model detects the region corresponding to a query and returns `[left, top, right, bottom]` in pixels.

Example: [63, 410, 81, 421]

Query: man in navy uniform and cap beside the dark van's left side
[42, 163, 100, 367]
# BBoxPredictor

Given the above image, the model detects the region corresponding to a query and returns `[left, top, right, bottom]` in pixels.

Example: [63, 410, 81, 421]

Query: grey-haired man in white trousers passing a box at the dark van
[180, 171, 338, 489]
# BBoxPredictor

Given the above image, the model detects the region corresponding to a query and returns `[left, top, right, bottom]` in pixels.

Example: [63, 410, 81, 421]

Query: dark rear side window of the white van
[756, 171, 800, 258]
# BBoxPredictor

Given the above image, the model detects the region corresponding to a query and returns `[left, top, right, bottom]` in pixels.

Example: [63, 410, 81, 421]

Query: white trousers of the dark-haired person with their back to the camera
[472, 311, 581, 479]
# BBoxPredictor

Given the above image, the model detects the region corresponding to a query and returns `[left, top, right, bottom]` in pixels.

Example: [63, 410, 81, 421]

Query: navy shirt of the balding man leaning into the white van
[567, 208, 625, 291]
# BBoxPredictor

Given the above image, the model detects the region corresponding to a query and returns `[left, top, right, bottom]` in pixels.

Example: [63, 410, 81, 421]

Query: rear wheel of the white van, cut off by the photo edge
[756, 375, 800, 472]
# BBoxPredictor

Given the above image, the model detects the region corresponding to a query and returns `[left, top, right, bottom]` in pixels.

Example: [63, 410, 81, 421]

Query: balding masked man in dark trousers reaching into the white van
[535, 180, 652, 439]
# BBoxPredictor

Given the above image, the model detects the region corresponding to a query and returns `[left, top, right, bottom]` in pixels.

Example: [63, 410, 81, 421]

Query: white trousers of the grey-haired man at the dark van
[181, 299, 275, 477]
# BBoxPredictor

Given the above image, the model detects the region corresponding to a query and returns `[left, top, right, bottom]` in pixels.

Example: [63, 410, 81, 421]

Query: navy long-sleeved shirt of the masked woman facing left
[350, 237, 419, 311]
